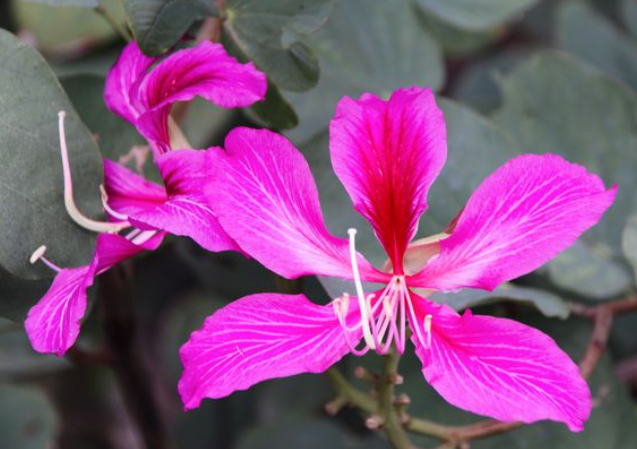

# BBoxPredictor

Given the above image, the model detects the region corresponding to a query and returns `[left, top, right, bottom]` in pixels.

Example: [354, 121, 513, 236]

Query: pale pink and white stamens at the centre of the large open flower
[333, 229, 432, 355]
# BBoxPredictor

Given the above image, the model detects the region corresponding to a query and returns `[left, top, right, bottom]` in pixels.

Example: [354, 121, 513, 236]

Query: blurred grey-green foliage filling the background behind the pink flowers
[0, 0, 637, 449]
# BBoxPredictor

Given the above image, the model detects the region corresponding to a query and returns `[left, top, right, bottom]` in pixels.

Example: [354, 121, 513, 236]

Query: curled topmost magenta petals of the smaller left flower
[104, 42, 267, 155]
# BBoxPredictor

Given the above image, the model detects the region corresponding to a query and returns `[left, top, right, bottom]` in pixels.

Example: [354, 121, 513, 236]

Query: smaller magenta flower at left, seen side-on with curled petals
[25, 43, 266, 355]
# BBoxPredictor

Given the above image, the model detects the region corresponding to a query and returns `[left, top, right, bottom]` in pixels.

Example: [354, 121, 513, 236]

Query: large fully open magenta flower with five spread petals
[179, 88, 615, 431]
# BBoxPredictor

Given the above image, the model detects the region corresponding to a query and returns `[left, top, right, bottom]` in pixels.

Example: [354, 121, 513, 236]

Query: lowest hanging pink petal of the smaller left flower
[24, 259, 97, 357]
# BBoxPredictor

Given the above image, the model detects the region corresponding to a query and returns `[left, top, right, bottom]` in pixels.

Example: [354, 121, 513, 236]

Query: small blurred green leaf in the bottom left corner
[0, 384, 58, 449]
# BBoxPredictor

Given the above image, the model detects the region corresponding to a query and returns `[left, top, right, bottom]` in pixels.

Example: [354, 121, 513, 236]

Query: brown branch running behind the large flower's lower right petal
[328, 298, 637, 448]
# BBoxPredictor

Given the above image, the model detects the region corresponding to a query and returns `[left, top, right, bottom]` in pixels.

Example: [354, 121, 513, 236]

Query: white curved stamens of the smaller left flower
[29, 111, 157, 272]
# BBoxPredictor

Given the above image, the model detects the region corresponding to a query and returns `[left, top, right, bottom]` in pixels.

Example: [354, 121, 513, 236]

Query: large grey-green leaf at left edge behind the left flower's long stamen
[0, 31, 102, 279]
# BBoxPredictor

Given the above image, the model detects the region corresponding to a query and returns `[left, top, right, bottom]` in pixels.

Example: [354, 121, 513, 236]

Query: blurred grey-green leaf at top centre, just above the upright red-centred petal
[286, 0, 444, 144]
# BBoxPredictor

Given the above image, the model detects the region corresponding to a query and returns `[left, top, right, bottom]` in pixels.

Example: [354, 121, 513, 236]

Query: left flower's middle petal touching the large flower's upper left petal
[129, 150, 240, 251]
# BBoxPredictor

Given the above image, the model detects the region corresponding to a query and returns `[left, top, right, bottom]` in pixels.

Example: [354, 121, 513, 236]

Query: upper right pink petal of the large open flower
[409, 154, 616, 291]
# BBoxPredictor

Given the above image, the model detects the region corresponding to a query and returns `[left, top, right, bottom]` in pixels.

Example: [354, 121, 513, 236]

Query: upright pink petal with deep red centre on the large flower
[330, 87, 447, 274]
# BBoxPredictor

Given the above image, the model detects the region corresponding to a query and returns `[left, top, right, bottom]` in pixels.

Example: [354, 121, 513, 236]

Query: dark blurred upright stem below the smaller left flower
[99, 267, 171, 449]
